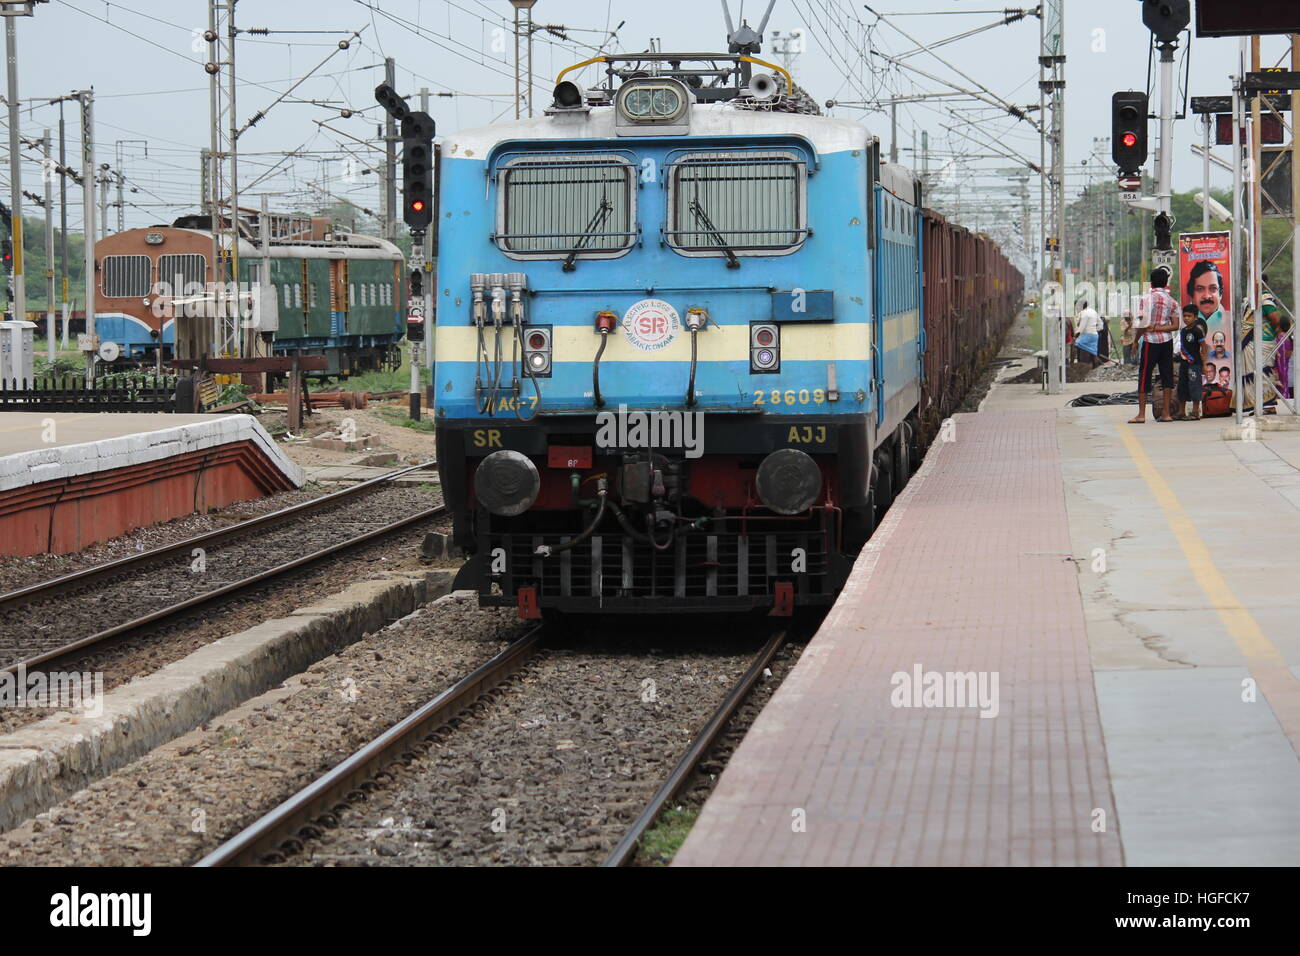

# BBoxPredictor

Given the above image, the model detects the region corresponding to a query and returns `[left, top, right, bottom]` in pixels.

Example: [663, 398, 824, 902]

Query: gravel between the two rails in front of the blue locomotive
[276, 622, 766, 866]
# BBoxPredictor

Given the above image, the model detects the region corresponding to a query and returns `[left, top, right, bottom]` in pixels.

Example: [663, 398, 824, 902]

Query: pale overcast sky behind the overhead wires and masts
[5, 0, 1284, 239]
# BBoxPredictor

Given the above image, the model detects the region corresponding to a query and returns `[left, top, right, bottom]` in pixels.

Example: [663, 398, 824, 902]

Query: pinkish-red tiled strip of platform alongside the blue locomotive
[676, 411, 1122, 865]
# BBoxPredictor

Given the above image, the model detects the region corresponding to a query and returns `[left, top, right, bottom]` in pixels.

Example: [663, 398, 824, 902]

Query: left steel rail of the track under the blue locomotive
[195, 624, 543, 866]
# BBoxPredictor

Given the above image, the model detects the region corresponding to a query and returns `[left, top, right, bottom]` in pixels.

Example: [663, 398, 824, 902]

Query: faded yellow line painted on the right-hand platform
[1119, 427, 1300, 757]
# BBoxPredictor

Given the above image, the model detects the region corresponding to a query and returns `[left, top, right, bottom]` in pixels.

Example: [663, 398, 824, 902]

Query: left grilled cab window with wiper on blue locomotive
[493, 155, 637, 258]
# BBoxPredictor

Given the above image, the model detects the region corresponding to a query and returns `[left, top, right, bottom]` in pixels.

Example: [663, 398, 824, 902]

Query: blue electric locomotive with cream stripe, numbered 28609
[436, 55, 1019, 617]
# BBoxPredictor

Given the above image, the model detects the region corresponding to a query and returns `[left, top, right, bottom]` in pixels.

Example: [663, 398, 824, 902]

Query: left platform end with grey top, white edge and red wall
[0, 412, 304, 555]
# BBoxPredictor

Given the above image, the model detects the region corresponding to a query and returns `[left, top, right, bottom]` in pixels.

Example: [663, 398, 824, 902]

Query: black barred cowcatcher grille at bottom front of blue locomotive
[489, 531, 836, 605]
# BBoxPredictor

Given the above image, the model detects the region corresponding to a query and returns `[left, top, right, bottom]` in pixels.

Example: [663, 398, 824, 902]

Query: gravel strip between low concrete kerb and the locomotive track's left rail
[0, 594, 520, 866]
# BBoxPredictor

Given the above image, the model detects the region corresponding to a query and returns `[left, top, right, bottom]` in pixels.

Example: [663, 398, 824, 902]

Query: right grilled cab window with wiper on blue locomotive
[664, 151, 809, 256]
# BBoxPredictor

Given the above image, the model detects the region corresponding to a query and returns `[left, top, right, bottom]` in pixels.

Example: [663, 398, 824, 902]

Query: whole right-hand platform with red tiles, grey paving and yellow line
[675, 369, 1300, 866]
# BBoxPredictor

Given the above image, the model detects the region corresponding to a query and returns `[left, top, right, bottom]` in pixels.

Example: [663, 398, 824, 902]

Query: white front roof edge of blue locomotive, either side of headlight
[442, 103, 871, 160]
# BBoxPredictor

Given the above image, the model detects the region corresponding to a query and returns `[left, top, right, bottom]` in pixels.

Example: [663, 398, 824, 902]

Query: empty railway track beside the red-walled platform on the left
[0, 464, 446, 674]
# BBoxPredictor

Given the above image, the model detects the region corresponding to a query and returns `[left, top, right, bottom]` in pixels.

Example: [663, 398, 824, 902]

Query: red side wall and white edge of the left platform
[0, 416, 302, 555]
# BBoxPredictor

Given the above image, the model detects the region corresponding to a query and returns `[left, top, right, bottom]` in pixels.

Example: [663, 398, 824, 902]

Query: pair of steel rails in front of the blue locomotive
[196, 626, 787, 866]
